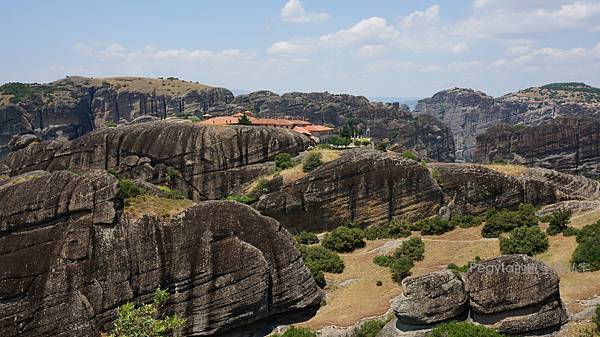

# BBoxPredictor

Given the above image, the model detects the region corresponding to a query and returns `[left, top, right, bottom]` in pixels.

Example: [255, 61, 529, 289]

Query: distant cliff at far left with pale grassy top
[0, 77, 233, 158]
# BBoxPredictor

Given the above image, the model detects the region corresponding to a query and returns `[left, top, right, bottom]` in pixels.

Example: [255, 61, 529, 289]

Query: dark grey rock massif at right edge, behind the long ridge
[474, 116, 600, 178]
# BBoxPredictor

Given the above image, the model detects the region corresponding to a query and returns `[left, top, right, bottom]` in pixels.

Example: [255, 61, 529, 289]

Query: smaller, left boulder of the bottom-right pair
[393, 270, 468, 325]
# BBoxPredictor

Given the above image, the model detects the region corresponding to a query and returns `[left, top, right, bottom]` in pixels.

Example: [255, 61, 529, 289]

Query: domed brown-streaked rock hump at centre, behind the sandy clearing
[256, 149, 442, 231]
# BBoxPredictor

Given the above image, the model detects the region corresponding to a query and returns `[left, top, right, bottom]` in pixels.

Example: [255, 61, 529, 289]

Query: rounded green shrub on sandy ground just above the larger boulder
[500, 226, 549, 256]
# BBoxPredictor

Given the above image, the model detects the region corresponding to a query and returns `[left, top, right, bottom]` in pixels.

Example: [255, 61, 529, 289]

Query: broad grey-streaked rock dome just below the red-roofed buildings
[0, 121, 311, 200]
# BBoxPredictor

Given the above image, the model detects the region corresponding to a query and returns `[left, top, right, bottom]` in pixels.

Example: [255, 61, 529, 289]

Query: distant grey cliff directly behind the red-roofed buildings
[232, 91, 454, 161]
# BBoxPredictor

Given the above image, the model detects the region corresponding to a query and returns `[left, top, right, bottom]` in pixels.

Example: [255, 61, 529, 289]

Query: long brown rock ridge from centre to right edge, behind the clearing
[255, 149, 600, 232]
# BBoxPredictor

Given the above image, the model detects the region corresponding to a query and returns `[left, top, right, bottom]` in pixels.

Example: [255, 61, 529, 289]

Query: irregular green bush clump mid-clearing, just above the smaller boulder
[373, 238, 425, 283]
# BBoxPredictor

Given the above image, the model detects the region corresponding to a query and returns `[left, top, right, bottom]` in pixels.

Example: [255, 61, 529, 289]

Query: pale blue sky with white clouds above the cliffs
[0, 0, 600, 97]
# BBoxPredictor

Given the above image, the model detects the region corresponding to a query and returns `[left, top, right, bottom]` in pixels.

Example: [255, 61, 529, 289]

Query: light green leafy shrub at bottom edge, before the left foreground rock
[109, 288, 186, 337]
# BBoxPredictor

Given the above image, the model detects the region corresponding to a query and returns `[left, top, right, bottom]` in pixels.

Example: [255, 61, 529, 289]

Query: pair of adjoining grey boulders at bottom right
[379, 255, 568, 337]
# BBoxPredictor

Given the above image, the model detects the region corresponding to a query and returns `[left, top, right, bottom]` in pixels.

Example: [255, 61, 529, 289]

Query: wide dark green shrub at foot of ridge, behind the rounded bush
[481, 204, 539, 238]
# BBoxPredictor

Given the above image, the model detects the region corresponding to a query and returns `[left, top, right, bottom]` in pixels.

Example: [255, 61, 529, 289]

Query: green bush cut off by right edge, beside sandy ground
[571, 221, 600, 271]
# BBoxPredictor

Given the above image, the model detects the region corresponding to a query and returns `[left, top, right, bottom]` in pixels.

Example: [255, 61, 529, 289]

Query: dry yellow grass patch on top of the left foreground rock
[124, 194, 194, 219]
